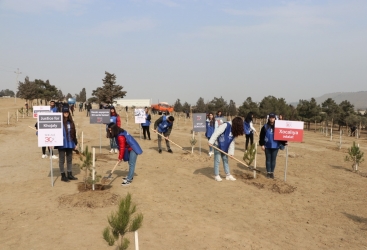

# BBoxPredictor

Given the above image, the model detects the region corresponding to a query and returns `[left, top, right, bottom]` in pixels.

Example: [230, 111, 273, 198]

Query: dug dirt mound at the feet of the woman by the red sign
[234, 173, 297, 194]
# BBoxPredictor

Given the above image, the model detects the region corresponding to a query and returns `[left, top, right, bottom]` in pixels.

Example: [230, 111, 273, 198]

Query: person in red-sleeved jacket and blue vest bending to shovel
[108, 122, 143, 186]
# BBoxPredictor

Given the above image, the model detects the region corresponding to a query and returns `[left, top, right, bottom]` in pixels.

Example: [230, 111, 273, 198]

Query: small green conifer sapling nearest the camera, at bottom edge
[102, 193, 143, 250]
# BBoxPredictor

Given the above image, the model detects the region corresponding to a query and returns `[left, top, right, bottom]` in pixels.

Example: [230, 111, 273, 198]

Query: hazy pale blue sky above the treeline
[0, 0, 367, 105]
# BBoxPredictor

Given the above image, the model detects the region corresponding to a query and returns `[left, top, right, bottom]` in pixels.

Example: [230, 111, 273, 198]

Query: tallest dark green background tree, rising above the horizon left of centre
[92, 71, 126, 103]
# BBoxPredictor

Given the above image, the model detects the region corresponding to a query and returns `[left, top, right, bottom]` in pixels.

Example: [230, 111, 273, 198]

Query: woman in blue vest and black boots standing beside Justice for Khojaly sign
[57, 106, 78, 182]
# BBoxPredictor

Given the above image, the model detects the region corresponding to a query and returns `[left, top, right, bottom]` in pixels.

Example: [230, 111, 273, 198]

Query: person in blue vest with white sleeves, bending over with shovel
[209, 117, 243, 181]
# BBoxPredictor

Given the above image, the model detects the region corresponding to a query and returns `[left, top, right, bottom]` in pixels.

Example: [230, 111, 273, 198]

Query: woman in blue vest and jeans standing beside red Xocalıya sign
[259, 113, 287, 179]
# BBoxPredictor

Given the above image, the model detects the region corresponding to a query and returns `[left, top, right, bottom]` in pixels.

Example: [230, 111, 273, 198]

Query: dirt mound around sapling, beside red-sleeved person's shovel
[58, 183, 120, 209]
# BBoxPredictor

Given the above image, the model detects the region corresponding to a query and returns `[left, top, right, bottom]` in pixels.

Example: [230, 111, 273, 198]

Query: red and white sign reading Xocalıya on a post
[274, 120, 303, 142]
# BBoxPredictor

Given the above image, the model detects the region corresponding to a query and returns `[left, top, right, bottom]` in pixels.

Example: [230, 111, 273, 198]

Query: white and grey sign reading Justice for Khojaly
[37, 112, 63, 147]
